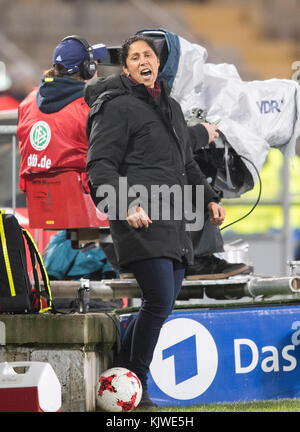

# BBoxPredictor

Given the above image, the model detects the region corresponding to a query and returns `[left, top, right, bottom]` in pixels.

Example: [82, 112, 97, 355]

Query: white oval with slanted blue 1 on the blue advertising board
[150, 318, 218, 400]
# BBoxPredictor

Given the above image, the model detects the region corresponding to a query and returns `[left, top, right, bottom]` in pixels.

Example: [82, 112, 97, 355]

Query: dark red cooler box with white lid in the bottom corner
[0, 361, 61, 412]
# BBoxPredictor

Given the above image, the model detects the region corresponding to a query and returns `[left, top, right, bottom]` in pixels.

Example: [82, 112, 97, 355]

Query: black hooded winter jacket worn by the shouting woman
[84, 75, 218, 266]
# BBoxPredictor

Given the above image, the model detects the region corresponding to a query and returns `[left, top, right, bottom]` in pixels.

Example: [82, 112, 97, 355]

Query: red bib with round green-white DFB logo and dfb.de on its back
[17, 88, 89, 190]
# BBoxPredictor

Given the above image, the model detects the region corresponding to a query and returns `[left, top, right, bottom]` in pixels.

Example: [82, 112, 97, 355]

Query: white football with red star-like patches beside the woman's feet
[97, 367, 143, 412]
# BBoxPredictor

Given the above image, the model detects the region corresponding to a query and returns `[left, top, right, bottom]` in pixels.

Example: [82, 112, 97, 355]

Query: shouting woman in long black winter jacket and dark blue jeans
[85, 35, 225, 406]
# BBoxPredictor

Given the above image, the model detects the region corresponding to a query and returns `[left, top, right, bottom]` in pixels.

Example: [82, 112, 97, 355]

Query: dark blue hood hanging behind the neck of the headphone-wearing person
[36, 77, 85, 114]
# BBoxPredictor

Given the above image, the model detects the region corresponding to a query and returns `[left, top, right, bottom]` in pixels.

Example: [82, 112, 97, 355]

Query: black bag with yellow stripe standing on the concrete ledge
[0, 210, 52, 313]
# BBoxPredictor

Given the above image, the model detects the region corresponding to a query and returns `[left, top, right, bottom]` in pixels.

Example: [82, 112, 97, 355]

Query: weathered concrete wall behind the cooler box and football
[0, 313, 119, 412]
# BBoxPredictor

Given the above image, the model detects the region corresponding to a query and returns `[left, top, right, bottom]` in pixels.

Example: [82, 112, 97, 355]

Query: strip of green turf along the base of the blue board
[135, 399, 300, 413]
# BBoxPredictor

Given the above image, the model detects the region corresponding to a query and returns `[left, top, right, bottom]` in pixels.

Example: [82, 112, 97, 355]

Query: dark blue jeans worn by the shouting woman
[114, 258, 185, 388]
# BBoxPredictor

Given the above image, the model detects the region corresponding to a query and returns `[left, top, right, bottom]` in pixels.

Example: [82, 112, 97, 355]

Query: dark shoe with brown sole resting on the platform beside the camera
[185, 255, 253, 280]
